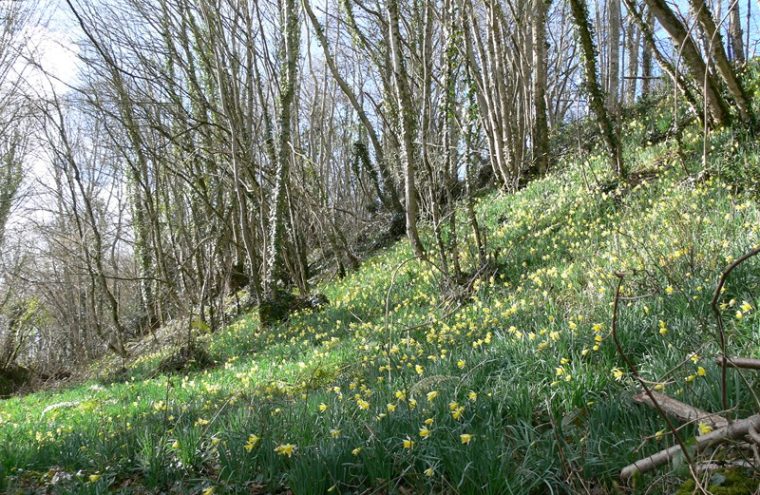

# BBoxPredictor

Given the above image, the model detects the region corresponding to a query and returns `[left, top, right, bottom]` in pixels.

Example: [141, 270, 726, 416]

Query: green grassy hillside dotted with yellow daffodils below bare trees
[0, 106, 760, 494]
